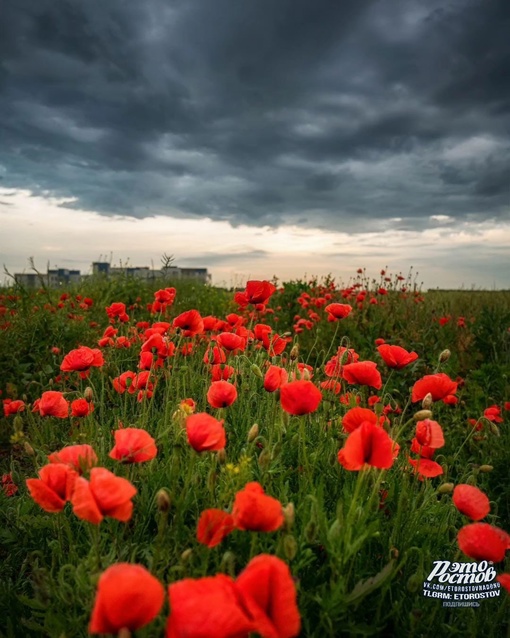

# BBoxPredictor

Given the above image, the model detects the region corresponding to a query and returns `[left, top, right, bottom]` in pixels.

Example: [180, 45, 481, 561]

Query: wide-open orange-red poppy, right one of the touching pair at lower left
[71, 467, 138, 525]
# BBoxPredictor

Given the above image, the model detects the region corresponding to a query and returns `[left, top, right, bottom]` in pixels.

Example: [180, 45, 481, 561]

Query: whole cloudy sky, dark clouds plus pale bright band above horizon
[0, 0, 510, 288]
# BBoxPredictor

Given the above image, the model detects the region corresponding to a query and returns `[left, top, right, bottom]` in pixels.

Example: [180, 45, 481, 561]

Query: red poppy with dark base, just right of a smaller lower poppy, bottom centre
[232, 481, 284, 532]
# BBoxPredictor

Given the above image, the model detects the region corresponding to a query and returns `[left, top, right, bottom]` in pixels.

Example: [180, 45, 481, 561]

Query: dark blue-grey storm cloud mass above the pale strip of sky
[0, 0, 510, 232]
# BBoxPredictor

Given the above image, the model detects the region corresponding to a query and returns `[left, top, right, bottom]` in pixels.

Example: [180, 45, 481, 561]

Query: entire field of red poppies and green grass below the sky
[0, 269, 510, 638]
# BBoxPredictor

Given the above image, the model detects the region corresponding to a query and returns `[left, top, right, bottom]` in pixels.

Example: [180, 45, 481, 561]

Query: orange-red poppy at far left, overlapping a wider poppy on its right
[26, 463, 78, 512]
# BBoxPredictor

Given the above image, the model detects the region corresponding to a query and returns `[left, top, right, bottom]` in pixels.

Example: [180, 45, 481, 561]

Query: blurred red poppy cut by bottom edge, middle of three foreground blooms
[166, 574, 253, 638]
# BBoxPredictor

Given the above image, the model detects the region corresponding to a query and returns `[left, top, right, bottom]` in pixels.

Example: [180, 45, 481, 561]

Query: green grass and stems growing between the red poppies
[0, 278, 510, 637]
